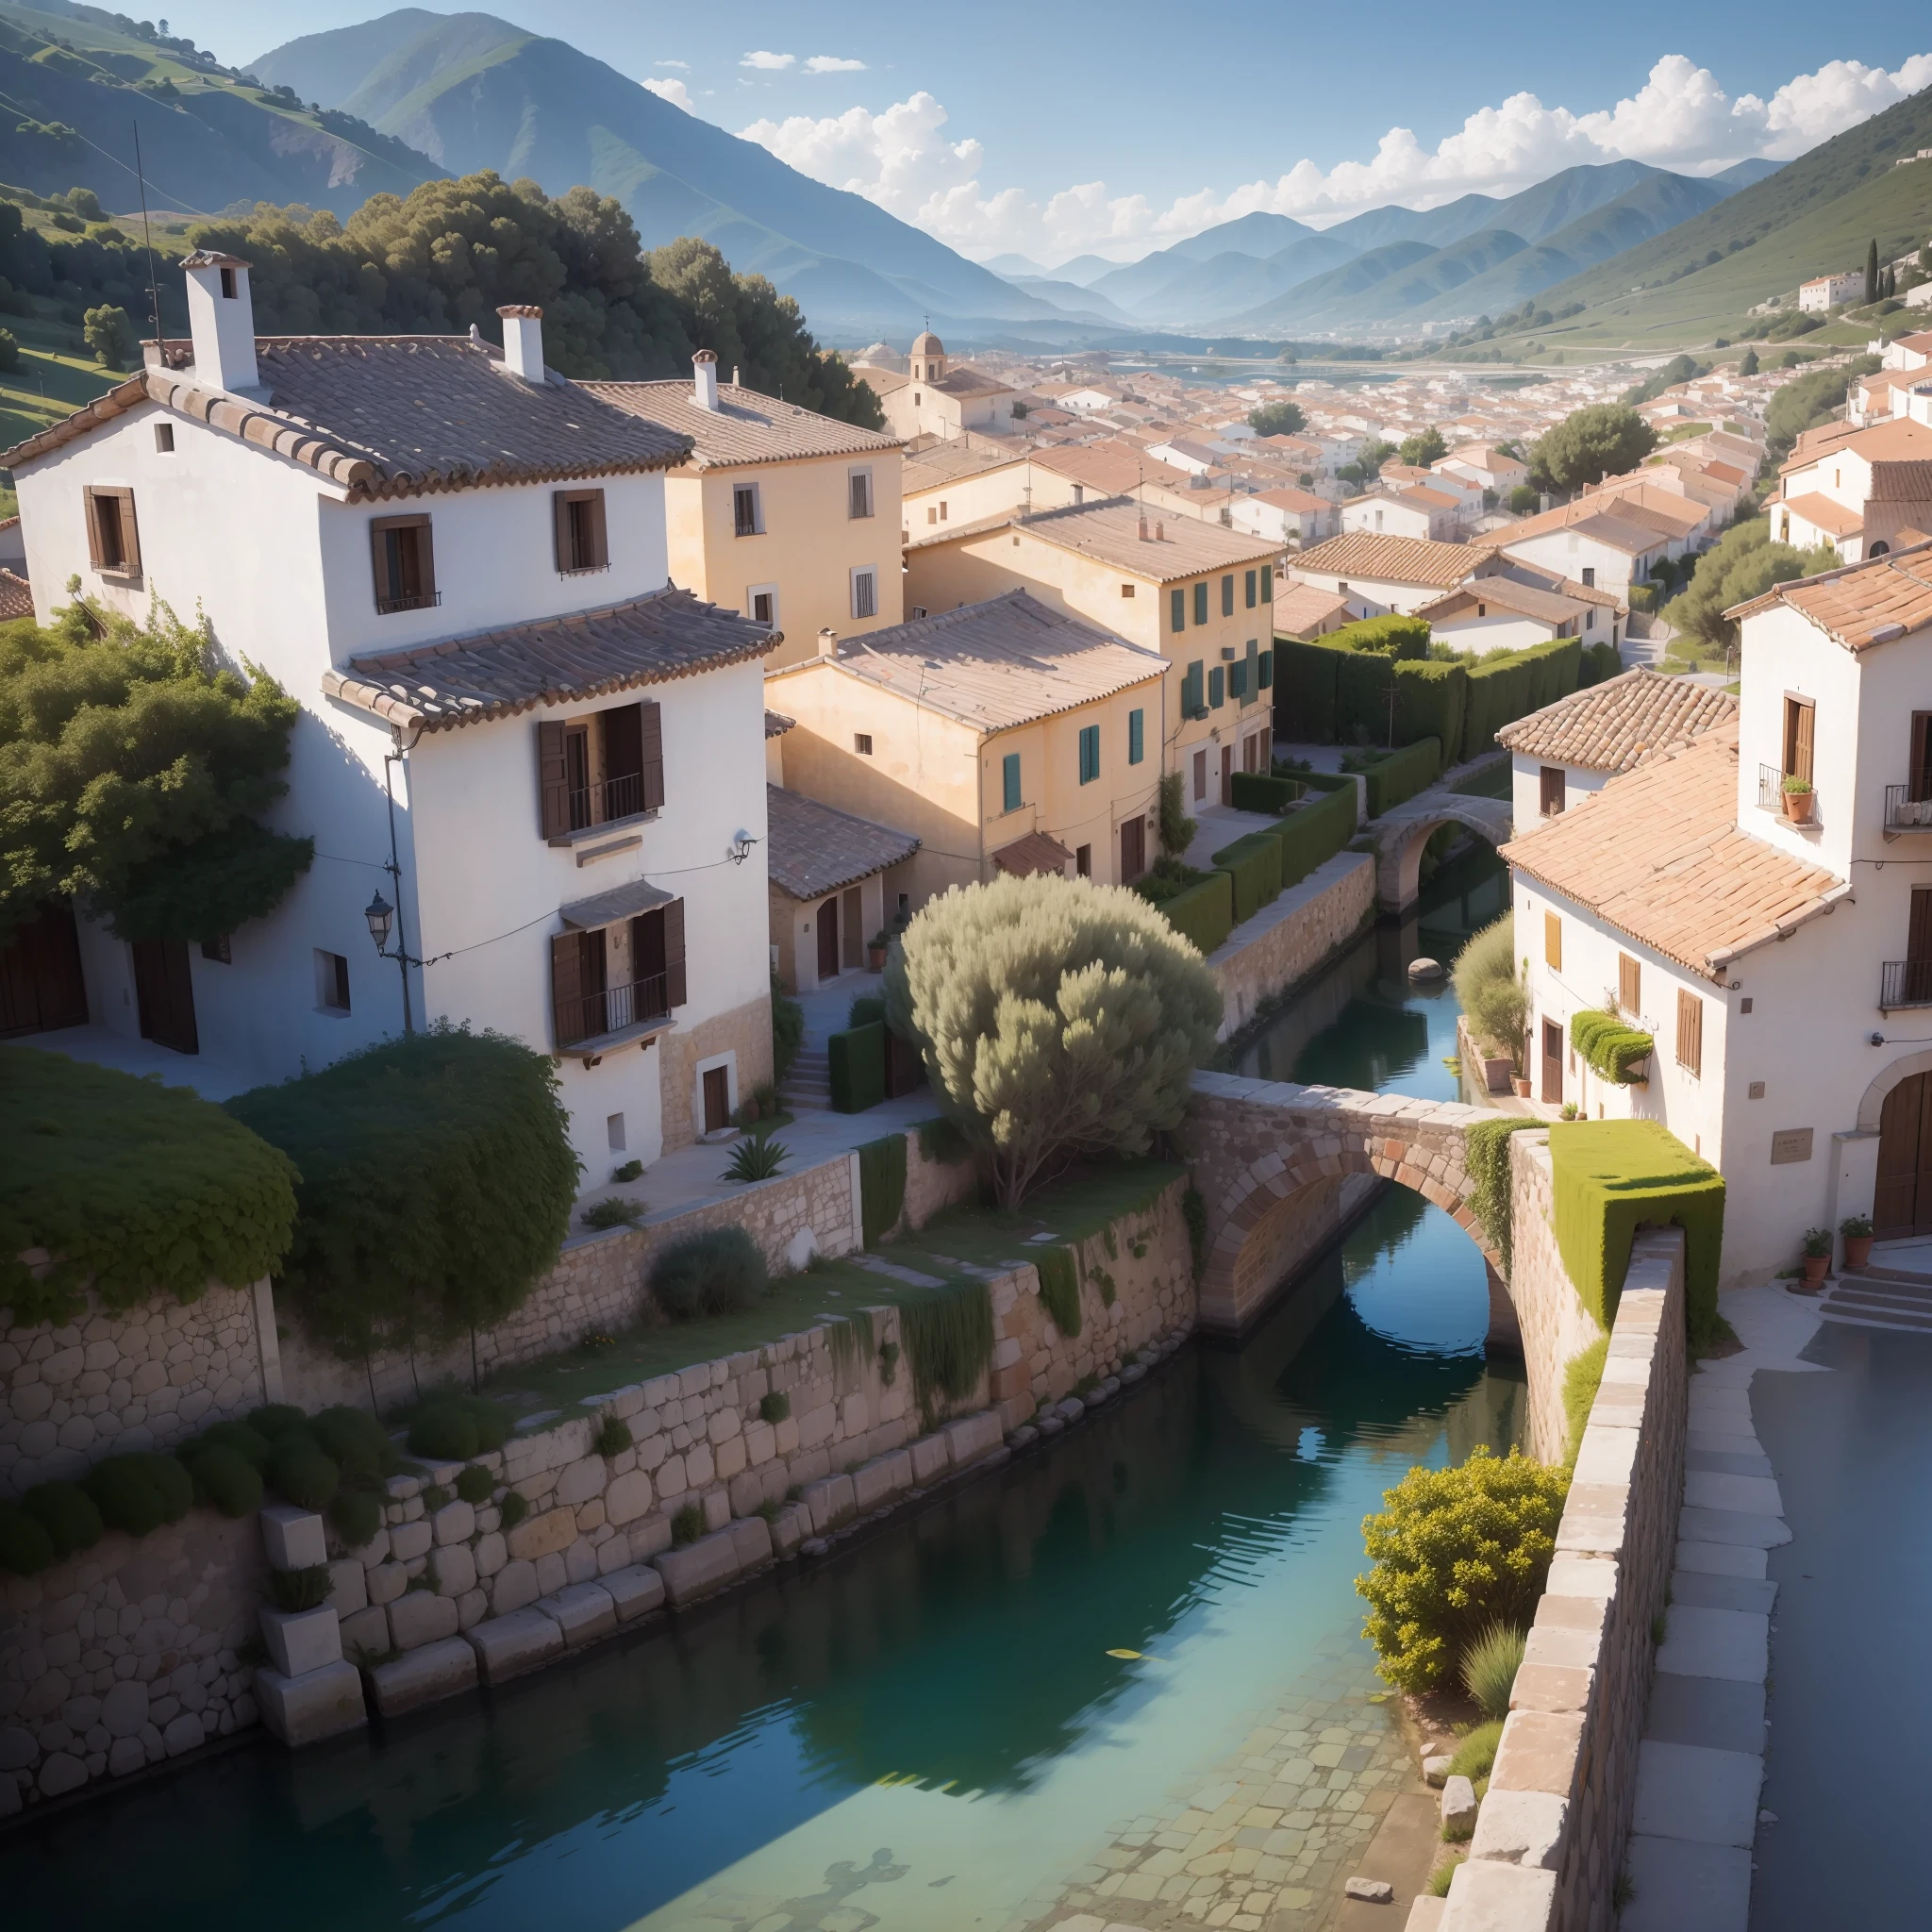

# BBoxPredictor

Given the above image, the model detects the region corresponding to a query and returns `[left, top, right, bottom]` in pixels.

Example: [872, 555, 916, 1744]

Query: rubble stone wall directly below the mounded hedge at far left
[0, 1283, 280, 1497]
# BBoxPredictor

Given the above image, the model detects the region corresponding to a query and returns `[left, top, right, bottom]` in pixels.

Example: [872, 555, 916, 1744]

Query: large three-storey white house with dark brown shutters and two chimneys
[0, 253, 774, 1184]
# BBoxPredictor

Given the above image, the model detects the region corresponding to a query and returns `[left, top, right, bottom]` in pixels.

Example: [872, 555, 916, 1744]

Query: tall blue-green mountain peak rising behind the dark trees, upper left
[253, 9, 1062, 340]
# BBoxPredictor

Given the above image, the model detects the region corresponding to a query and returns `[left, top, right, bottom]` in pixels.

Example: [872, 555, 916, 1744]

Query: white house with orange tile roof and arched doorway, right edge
[1505, 542, 1932, 1283]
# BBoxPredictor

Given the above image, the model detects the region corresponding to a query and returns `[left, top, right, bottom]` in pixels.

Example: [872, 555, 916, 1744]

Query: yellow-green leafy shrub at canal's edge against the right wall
[1355, 1447, 1569, 1692]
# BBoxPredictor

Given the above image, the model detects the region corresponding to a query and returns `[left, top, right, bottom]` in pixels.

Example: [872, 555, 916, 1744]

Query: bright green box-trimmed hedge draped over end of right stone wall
[1549, 1121, 1724, 1341]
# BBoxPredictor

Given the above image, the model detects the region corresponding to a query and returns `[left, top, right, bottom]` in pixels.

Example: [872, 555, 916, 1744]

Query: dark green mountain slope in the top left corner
[0, 0, 442, 214]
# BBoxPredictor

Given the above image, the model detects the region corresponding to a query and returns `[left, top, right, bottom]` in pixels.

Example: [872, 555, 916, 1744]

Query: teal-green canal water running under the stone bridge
[0, 854, 1524, 1932]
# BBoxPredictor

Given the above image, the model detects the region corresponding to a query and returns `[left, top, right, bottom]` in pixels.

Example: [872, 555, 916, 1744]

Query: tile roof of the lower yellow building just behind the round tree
[769, 590, 1167, 732]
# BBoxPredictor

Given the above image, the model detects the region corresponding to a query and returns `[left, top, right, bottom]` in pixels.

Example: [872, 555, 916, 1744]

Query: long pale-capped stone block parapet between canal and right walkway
[1438, 1223, 1687, 1932]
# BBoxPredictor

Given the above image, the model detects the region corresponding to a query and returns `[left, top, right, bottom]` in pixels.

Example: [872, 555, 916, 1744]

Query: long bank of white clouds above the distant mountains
[741, 54, 1932, 258]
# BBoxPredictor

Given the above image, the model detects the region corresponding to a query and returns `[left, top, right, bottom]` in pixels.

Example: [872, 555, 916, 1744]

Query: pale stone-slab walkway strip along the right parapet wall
[1619, 1287, 1824, 1932]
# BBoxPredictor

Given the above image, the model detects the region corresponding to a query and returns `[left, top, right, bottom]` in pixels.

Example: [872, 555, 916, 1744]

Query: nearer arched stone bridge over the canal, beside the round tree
[1180, 1073, 1513, 1335]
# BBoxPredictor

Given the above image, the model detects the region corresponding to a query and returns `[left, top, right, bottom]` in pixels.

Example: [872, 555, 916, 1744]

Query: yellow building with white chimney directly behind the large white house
[581, 350, 904, 665]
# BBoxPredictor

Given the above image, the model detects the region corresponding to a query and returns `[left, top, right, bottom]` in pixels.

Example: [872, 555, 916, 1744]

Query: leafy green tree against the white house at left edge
[0, 599, 315, 942]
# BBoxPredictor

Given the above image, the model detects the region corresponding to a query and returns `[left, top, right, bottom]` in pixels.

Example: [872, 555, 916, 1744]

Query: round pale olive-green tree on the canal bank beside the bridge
[885, 875, 1221, 1208]
